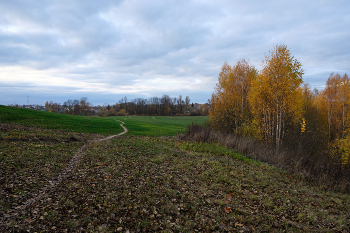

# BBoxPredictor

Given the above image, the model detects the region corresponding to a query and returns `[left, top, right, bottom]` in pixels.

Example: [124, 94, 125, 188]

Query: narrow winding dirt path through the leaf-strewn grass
[0, 123, 128, 226]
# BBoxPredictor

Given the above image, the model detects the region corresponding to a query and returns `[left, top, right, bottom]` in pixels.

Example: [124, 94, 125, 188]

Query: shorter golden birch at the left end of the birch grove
[210, 59, 257, 134]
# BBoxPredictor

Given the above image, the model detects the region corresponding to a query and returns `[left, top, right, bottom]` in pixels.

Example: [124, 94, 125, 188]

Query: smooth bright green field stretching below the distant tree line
[0, 105, 209, 136]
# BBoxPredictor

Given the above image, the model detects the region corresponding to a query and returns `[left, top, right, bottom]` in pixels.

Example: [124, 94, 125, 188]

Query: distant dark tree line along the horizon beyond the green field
[45, 95, 209, 117]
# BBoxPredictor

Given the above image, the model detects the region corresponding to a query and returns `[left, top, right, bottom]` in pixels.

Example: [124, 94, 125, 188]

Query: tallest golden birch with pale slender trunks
[250, 45, 303, 149]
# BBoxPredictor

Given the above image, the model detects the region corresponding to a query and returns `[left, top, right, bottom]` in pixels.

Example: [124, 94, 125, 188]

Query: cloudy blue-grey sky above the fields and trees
[0, 0, 350, 105]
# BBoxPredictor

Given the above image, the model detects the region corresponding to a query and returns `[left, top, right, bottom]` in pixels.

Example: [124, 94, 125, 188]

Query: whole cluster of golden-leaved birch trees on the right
[209, 45, 350, 164]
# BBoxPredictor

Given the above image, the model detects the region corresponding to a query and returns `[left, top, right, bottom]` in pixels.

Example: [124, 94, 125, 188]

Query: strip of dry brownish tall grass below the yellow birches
[179, 124, 350, 193]
